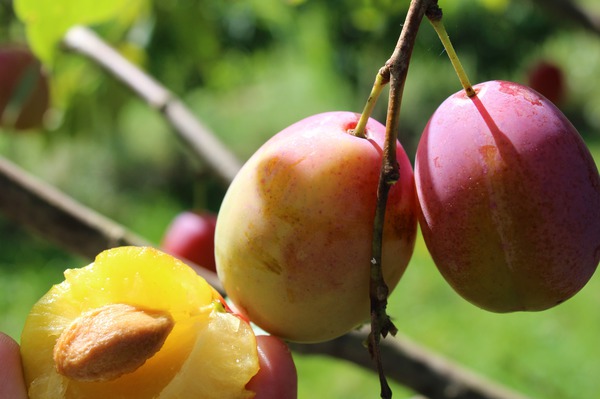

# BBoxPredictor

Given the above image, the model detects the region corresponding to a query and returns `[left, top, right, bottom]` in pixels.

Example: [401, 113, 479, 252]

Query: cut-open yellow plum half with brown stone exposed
[21, 247, 258, 399]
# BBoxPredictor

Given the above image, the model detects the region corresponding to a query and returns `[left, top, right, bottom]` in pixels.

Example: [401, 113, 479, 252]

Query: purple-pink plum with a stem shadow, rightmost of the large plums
[415, 81, 600, 312]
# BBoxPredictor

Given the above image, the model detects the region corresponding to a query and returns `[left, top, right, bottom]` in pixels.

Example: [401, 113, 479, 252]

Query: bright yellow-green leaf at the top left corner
[14, 0, 139, 64]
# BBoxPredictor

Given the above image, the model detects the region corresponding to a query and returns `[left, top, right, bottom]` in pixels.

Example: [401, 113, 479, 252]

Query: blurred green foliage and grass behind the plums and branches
[0, 0, 600, 399]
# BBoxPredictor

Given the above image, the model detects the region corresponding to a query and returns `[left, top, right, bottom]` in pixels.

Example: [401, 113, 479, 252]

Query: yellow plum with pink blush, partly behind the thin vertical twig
[215, 112, 417, 342]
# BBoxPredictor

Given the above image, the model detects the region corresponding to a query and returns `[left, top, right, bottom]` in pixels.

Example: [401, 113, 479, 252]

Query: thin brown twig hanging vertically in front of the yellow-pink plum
[365, 0, 438, 399]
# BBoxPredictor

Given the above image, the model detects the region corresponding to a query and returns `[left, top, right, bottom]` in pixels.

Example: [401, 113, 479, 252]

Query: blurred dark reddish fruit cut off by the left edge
[0, 46, 49, 130]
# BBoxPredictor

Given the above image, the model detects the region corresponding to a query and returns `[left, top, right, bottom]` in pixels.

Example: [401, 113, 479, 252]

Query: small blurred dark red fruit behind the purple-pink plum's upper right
[527, 60, 566, 105]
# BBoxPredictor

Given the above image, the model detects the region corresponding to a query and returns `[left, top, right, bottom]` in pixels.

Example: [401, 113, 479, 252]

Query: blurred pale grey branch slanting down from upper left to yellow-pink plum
[63, 26, 241, 186]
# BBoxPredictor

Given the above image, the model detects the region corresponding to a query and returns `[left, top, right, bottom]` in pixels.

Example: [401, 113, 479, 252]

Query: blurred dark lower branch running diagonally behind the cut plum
[0, 155, 525, 399]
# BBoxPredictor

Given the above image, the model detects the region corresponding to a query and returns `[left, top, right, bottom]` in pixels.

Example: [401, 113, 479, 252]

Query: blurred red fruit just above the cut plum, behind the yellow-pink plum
[161, 211, 217, 271]
